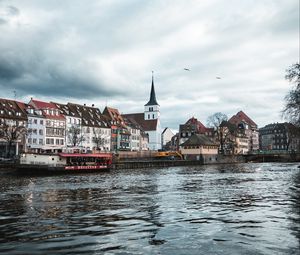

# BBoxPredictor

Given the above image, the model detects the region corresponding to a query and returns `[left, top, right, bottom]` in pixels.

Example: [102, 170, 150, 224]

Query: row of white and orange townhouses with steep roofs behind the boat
[0, 99, 149, 157]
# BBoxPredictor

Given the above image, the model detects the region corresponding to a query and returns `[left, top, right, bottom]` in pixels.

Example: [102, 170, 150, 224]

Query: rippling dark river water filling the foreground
[0, 163, 300, 255]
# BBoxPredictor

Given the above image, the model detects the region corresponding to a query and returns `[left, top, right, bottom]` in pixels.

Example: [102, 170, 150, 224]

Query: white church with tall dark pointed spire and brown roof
[123, 73, 162, 150]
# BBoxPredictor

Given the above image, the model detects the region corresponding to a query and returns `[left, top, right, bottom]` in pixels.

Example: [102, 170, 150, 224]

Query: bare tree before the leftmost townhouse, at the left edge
[0, 120, 27, 158]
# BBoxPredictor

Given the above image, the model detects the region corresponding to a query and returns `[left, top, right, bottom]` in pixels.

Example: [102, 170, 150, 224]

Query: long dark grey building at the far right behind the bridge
[259, 122, 300, 151]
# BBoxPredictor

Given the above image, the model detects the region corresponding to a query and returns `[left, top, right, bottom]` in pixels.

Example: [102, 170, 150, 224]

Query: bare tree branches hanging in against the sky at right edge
[283, 63, 300, 126]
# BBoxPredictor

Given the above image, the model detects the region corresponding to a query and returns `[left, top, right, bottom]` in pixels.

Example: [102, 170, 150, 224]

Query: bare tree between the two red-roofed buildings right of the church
[207, 112, 229, 154]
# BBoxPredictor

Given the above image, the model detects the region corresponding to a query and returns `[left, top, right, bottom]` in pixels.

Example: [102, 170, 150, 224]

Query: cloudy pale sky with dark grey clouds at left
[0, 0, 300, 130]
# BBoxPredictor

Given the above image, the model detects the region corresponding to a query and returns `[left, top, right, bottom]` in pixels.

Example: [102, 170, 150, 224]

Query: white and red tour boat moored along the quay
[17, 153, 112, 173]
